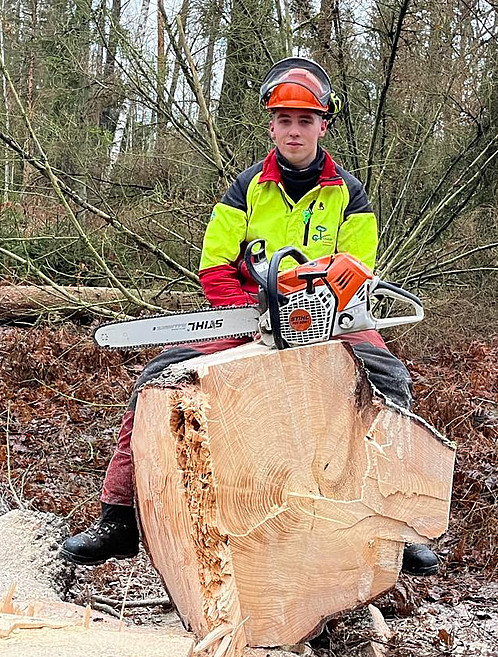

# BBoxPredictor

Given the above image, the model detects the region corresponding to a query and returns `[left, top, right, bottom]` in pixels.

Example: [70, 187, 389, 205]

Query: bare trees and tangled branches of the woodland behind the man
[0, 0, 498, 341]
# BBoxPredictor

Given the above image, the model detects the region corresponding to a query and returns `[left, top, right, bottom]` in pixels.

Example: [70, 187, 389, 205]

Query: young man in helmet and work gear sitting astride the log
[61, 57, 437, 574]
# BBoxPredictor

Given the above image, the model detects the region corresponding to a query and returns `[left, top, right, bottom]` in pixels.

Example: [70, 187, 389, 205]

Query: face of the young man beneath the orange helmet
[270, 109, 327, 169]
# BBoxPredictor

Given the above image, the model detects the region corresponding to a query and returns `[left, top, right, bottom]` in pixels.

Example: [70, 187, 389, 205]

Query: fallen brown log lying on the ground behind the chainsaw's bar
[0, 285, 205, 320]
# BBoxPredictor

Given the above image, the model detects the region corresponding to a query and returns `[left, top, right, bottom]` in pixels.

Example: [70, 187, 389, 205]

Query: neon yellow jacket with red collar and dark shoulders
[199, 149, 377, 306]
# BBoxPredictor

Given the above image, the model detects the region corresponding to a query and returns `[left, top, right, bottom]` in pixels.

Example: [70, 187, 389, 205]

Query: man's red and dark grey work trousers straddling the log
[101, 330, 390, 506]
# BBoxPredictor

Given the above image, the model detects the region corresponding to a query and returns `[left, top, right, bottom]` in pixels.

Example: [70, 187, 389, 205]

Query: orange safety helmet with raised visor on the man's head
[260, 57, 342, 118]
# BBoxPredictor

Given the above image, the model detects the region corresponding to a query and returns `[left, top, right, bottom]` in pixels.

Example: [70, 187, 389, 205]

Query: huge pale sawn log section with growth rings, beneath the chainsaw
[132, 342, 454, 654]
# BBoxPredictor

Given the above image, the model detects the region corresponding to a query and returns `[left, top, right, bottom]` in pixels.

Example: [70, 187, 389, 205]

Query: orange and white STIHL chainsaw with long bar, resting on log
[94, 239, 424, 349]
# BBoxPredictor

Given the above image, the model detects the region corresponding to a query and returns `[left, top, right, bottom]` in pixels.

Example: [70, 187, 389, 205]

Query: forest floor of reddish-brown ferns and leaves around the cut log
[0, 325, 498, 657]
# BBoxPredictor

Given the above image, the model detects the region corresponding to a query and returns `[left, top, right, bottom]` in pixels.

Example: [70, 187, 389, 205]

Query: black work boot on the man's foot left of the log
[60, 502, 139, 566]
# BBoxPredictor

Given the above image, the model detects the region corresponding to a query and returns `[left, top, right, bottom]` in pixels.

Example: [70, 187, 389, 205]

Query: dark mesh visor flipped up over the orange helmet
[260, 57, 332, 107]
